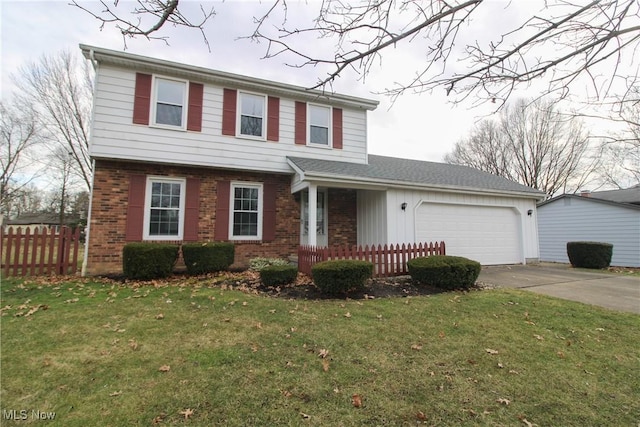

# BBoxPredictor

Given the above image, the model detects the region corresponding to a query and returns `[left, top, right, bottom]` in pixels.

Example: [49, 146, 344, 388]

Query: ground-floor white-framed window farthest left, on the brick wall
[143, 177, 186, 240]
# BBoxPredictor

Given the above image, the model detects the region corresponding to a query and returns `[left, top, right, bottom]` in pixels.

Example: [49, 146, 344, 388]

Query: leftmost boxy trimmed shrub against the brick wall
[122, 243, 180, 280]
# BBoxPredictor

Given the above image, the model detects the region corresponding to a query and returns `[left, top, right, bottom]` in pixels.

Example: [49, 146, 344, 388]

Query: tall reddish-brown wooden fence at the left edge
[0, 227, 80, 277]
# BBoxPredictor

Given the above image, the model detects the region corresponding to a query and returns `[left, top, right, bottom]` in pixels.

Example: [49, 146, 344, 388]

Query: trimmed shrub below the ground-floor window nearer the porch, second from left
[182, 242, 235, 274]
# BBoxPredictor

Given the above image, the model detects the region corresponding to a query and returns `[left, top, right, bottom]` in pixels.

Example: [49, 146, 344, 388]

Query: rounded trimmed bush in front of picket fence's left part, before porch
[311, 260, 373, 295]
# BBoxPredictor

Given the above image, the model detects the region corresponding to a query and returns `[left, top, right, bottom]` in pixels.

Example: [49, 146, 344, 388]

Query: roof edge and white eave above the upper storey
[80, 44, 379, 110]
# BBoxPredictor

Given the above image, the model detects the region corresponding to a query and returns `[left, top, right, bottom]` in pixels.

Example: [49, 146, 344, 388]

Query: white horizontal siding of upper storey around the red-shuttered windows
[91, 65, 366, 172]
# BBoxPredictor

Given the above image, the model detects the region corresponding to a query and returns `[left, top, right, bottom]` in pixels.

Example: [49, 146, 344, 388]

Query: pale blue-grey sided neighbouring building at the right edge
[538, 193, 640, 267]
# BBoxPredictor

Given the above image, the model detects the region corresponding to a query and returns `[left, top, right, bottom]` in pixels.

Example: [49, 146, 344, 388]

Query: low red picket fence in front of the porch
[298, 242, 446, 277]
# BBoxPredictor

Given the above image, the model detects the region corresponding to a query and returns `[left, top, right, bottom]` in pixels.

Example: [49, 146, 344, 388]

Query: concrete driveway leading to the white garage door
[478, 263, 640, 314]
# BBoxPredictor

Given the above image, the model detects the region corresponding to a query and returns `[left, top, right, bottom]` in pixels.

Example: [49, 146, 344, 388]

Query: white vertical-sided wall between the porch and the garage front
[357, 190, 388, 245]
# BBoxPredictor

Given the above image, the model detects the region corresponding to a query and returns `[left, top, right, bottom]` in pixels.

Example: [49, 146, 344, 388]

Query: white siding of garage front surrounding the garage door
[387, 189, 539, 263]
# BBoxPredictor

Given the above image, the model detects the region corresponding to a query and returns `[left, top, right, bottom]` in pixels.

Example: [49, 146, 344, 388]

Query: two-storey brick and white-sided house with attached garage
[81, 45, 544, 274]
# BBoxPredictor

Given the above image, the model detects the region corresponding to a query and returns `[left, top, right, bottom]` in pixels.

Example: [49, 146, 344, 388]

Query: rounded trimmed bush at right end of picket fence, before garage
[407, 255, 480, 289]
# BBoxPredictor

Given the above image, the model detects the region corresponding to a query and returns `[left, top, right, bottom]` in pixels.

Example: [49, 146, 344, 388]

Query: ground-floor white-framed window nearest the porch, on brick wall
[229, 182, 263, 240]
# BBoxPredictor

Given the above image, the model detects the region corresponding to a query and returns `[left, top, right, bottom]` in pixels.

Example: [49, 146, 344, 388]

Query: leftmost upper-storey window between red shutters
[153, 77, 187, 129]
